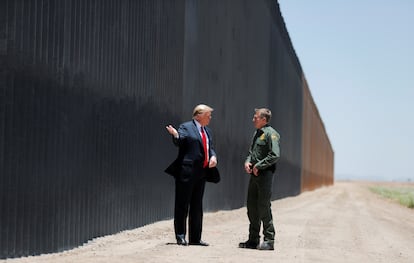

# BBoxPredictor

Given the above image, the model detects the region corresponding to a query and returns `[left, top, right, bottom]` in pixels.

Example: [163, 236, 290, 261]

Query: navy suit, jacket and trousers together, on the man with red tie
[165, 121, 217, 243]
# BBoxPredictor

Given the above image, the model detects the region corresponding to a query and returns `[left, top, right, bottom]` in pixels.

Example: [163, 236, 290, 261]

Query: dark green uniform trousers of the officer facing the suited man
[247, 170, 275, 244]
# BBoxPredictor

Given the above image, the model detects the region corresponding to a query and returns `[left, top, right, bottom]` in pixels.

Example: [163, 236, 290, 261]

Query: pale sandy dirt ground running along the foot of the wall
[0, 182, 414, 263]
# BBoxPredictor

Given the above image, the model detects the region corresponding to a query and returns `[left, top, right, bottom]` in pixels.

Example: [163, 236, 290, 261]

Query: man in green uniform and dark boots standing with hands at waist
[239, 108, 280, 250]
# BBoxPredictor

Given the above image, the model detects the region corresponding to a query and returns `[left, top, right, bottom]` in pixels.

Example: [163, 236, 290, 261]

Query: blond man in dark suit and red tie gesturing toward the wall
[165, 104, 217, 246]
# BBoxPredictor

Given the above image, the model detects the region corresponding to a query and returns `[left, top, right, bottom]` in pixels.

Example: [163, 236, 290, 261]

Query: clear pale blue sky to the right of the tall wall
[278, 0, 414, 181]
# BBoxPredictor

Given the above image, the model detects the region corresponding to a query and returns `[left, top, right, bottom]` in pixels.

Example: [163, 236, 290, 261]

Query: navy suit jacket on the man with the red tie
[165, 121, 218, 182]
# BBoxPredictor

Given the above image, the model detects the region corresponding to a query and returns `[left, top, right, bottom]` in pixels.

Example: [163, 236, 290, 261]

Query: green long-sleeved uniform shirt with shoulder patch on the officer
[246, 124, 280, 170]
